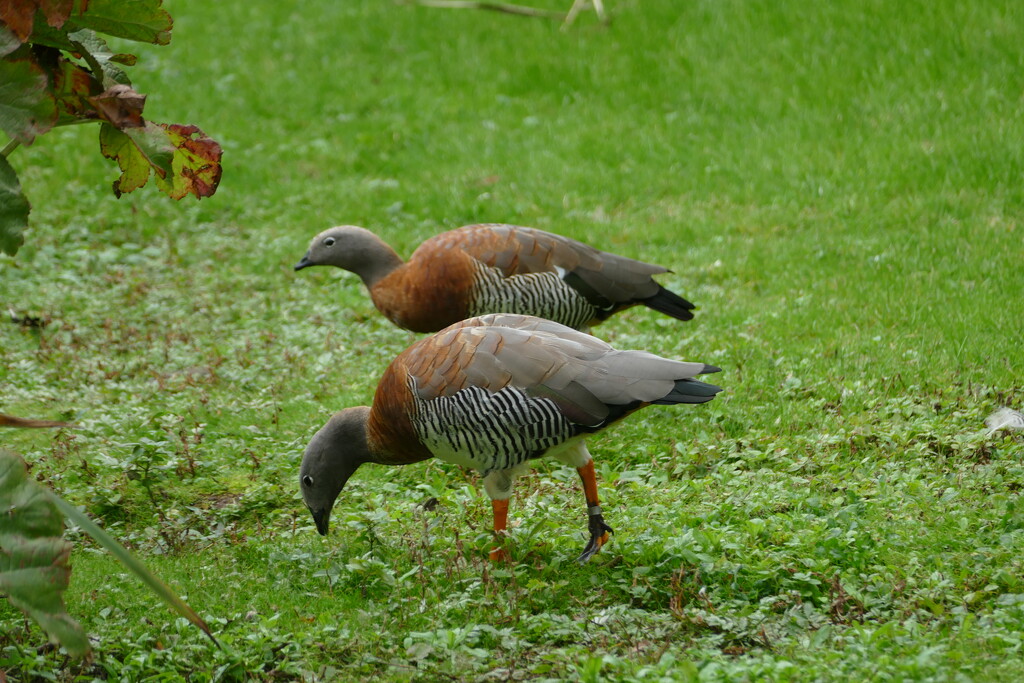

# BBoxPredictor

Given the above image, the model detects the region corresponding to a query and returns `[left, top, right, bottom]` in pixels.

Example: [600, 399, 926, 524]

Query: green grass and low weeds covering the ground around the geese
[0, 0, 1024, 682]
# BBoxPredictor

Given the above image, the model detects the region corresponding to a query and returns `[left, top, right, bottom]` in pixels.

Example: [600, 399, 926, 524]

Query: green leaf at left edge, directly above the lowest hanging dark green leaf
[0, 50, 57, 144]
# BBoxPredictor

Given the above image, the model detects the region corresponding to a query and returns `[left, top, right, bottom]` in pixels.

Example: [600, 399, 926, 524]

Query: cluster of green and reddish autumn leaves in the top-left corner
[0, 0, 221, 254]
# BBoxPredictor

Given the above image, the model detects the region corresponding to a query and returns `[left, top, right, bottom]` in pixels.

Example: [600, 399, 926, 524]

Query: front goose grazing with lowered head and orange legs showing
[299, 313, 721, 561]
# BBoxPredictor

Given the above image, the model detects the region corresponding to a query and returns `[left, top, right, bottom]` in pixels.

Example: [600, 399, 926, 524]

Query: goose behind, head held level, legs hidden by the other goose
[295, 224, 694, 332]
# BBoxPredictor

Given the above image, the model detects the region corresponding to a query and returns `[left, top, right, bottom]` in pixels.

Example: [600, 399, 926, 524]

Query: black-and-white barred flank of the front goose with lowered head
[411, 381, 577, 474]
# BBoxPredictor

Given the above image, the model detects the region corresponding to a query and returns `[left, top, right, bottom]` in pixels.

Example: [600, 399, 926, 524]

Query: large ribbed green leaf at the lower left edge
[0, 451, 89, 657]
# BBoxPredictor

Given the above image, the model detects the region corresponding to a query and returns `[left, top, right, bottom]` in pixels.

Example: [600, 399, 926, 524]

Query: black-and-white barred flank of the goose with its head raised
[470, 264, 594, 329]
